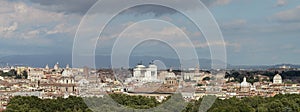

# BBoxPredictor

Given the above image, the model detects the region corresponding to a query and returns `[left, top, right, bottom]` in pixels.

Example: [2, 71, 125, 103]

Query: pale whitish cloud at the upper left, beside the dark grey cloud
[0, 0, 81, 39]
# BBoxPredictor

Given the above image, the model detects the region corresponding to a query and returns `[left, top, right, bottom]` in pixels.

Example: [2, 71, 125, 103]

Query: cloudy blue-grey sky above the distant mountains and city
[0, 0, 300, 65]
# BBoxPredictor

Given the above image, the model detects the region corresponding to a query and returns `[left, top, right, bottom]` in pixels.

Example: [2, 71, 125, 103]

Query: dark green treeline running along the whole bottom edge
[6, 94, 300, 112]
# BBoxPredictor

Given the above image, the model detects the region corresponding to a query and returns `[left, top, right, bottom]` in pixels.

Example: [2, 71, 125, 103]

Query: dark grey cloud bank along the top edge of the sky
[29, 0, 232, 15]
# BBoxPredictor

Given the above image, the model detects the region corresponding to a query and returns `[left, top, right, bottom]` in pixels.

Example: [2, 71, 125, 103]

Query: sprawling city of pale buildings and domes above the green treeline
[0, 63, 300, 109]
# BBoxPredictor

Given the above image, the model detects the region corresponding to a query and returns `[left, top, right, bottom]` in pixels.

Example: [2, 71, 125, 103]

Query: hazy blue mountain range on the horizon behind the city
[0, 55, 300, 69]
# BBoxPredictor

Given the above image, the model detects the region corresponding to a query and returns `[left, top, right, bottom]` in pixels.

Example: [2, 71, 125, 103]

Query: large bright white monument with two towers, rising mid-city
[133, 63, 158, 82]
